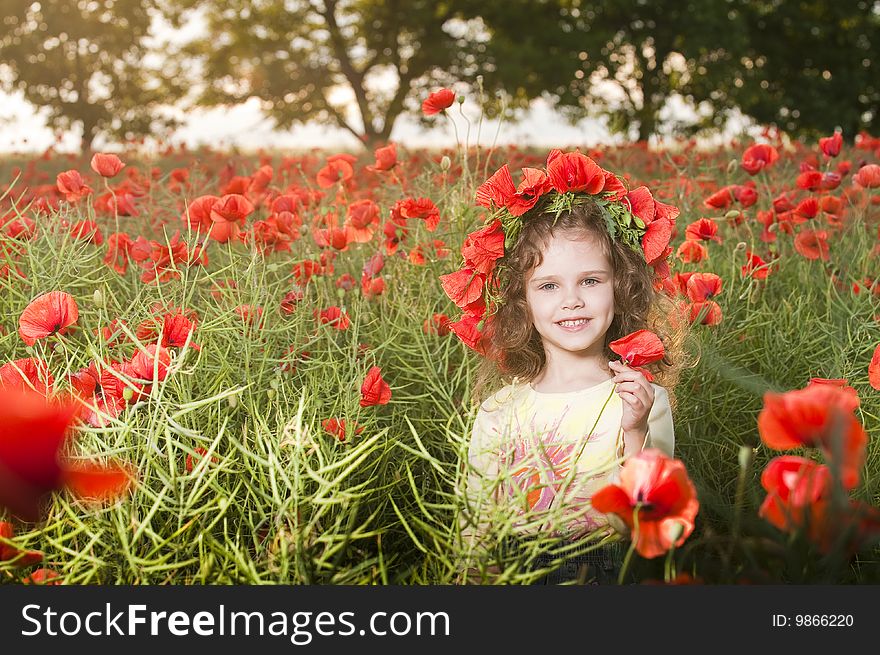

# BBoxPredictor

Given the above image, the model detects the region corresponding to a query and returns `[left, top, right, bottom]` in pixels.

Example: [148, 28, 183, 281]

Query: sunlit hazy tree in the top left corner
[0, 0, 181, 151]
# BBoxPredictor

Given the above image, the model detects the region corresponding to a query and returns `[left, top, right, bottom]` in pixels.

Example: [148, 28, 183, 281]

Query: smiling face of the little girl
[526, 233, 614, 359]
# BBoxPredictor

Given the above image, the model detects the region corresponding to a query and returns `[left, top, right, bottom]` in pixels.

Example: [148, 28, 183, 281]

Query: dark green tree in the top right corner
[715, 0, 880, 138]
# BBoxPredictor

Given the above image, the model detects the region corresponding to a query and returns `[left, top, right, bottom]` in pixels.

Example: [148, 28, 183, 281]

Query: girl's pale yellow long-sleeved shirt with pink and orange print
[467, 379, 675, 538]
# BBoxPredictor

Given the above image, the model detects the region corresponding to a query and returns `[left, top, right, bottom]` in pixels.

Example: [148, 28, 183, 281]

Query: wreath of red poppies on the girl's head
[440, 150, 679, 355]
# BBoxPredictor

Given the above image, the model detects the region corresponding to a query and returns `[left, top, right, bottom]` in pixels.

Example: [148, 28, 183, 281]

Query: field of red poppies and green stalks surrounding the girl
[0, 116, 880, 584]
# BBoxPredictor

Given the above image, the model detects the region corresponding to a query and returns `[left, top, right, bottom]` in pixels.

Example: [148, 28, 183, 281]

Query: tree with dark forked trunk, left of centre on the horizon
[165, 0, 488, 146]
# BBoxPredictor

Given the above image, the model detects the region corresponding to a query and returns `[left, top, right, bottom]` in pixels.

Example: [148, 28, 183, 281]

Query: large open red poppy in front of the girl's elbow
[592, 448, 700, 559]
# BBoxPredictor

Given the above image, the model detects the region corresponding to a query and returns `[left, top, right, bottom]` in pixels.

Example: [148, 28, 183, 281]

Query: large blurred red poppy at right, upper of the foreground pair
[758, 384, 868, 489]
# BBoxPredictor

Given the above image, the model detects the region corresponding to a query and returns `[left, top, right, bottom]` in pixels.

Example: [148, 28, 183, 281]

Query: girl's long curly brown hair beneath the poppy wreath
[472, 199, 689, 409]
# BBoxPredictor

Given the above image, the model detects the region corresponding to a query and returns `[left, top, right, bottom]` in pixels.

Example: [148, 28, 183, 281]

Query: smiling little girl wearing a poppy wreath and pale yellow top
[443, 151, 678, 583]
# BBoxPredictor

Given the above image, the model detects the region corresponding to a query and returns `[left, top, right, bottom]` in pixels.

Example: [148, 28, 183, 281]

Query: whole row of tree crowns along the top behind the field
[0, 0, 880, 146]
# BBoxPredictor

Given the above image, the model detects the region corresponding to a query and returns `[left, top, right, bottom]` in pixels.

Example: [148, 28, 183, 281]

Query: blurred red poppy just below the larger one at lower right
[758, 455, 831, 532]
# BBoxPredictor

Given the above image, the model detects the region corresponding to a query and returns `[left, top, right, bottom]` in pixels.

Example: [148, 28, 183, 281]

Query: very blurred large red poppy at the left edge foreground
[0, 388, 131, 521]
